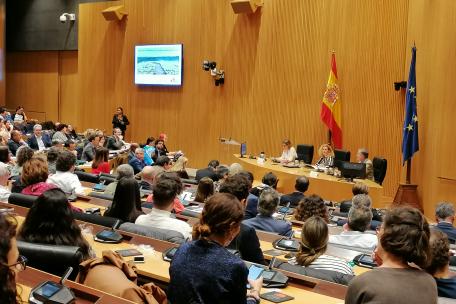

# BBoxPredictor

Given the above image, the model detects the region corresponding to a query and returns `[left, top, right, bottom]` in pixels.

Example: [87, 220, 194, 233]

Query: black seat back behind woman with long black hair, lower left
[17, 241, 84, 280]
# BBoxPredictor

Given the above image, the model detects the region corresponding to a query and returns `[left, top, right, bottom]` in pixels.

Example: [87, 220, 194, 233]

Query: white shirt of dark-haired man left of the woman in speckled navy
[135, 208, 192, 239]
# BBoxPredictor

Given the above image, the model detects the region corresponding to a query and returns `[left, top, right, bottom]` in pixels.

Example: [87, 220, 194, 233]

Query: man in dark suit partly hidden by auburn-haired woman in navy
[219, 174, 265, 264]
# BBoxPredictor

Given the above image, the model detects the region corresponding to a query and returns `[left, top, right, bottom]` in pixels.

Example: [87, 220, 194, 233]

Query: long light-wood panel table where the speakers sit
[234, 155, 387, 208]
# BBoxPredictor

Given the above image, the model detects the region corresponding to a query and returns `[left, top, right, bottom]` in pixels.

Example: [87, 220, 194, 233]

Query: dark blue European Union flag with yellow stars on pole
[402, 47, 419, 164]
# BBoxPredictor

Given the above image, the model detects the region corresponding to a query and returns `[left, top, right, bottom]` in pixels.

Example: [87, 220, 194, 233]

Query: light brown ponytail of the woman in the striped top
[296, 216, 329, 266]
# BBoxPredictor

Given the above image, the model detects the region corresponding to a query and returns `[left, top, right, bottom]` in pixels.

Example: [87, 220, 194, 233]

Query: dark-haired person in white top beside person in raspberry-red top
[48, 151, 84, 195]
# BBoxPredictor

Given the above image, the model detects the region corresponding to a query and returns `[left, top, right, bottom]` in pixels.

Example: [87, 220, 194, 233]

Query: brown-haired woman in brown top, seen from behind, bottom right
[345, 207, 437, 304]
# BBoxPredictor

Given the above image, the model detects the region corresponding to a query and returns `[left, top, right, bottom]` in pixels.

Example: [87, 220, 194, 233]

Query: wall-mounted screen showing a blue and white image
[135, 44, 182, 86]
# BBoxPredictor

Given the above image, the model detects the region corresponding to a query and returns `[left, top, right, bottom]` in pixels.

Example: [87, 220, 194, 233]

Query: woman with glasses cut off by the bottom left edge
[0, 213, 26, 304]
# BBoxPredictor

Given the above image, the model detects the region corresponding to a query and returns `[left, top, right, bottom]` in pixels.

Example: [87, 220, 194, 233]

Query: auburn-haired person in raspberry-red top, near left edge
[21, 157, 56, 196]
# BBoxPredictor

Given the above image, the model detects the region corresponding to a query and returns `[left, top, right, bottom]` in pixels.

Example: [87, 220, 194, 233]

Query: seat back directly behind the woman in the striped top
[274, 261, 354, 285]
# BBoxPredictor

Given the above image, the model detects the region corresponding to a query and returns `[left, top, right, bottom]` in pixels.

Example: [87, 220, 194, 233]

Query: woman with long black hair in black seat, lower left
[18, 189, 95, 259]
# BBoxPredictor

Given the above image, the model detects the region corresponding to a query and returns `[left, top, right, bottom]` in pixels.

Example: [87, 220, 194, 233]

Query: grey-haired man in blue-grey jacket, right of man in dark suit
[243, 188, 293, 237]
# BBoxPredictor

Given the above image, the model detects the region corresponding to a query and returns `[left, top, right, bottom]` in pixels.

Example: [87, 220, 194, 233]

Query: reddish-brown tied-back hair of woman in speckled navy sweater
[192, 193, 244, 240]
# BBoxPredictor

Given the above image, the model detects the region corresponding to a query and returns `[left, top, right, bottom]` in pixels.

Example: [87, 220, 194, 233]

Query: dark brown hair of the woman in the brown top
[380, 207, 431, 269]
